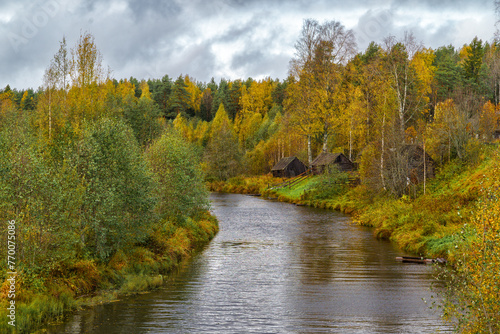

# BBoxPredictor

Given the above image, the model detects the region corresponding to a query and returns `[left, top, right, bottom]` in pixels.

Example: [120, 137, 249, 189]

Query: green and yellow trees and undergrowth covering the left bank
[0, 34, 217, 331]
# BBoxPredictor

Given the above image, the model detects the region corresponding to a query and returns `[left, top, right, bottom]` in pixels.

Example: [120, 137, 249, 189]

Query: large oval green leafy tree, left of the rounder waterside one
[74, 119, 155, 261]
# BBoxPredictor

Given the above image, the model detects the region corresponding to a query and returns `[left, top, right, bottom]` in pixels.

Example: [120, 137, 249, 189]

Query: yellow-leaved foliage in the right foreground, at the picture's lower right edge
[444, 153, 500, 333]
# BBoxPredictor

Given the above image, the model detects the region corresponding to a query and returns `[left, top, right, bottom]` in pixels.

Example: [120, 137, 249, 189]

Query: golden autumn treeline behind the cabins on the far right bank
[169, 20, 500, 196]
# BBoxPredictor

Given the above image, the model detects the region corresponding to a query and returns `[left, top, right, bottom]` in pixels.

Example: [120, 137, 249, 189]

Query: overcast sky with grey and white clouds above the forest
[0, 0, 495, 89]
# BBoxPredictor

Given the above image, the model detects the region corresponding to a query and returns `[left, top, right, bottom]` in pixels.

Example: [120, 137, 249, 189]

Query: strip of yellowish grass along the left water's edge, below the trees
[0, 212, 218, 333]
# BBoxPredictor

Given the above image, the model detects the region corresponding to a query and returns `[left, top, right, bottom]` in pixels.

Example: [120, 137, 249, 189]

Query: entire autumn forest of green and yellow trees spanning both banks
[0, 19, 500, 332]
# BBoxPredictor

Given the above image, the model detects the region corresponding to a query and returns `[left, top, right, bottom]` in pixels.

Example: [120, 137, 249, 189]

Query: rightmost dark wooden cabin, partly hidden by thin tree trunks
[403, 145, 435, 184]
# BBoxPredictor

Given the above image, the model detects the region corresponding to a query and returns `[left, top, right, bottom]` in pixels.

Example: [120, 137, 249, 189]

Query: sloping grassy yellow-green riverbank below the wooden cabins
[209, 150, 500, 261]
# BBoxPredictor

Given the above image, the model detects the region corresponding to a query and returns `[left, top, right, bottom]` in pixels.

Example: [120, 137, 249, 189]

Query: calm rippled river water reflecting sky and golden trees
[49, 194, 451, 334]
